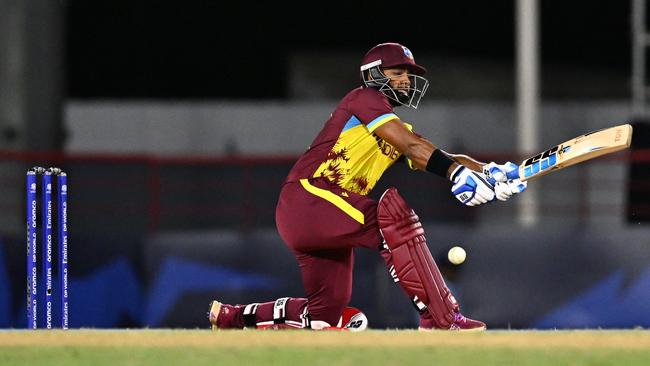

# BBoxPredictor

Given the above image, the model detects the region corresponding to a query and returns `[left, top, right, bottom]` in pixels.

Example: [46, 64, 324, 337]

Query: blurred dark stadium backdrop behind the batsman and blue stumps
[0, 0, 650, 328]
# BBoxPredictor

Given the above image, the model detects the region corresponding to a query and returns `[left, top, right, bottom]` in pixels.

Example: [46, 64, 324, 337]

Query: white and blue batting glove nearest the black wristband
[451, 165, 495, 206]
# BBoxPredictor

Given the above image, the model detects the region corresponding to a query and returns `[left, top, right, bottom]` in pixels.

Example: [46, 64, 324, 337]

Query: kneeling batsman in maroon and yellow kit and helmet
[209, 43, 526, 331]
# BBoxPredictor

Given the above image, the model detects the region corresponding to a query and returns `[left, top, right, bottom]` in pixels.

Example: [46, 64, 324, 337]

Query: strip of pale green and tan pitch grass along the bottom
[0, 330, 650, 366]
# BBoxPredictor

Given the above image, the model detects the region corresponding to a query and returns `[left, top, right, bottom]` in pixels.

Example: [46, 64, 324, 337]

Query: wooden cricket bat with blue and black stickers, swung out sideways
[508, 124, 632, 181]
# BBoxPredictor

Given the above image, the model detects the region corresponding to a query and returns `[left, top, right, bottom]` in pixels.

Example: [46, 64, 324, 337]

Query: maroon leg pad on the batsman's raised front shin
[377, 187, 458, 328]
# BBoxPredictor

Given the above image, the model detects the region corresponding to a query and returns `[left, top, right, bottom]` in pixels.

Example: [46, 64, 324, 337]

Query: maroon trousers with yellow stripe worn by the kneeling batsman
[276, 178, 390, 325]
